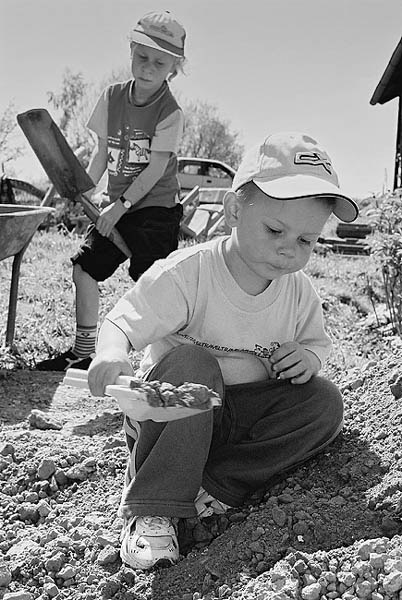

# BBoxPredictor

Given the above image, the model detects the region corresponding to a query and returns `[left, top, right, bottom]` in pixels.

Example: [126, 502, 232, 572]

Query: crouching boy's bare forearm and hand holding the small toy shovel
[88, 319, 134, 396]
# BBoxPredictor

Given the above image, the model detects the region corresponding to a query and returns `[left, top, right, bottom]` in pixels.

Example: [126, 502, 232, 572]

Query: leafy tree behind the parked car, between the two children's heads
[179, 101, 244, 169]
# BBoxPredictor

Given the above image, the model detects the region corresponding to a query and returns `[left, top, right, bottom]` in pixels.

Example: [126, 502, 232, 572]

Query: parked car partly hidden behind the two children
[177, 156, 236, 195]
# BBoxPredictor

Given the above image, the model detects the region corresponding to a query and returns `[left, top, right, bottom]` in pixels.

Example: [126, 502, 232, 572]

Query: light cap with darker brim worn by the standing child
[129, 10, 186, 58]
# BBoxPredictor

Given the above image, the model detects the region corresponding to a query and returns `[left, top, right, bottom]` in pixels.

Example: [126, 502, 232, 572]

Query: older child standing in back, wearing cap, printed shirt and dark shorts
[36, 12, 186, 371]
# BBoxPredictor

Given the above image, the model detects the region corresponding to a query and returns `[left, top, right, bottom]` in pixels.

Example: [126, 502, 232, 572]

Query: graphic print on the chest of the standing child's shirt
[108, 125, 151, 179]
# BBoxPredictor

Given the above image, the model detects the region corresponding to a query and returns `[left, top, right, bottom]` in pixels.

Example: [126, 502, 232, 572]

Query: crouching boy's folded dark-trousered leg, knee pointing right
[203, 377, 343, 506]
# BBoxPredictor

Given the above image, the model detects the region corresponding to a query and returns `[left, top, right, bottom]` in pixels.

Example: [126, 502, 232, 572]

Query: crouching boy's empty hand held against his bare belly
[270, 342, 321, 383]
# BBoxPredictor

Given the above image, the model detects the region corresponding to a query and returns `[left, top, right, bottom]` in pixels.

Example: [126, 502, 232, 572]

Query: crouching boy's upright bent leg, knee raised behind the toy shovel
[119, 345, 223, 519]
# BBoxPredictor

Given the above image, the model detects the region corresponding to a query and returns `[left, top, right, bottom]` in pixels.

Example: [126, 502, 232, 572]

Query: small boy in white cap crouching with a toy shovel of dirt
[88, 133, 358, 569]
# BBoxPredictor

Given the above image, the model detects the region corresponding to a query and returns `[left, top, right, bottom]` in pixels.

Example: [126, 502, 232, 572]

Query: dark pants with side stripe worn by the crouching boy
[120, 345, 343, 518]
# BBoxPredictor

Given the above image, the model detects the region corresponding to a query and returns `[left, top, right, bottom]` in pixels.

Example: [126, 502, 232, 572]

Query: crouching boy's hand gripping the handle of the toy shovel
[88, 350, 134, 396]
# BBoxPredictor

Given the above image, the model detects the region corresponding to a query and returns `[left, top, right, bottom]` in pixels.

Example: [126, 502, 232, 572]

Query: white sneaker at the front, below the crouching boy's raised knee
[120, 516, 179, 569]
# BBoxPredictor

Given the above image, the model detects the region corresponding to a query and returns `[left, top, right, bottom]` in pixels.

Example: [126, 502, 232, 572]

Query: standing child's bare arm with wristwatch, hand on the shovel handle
[96, 151, 170, 237]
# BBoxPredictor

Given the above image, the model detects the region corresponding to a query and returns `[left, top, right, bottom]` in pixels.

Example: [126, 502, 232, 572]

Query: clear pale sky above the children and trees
[0, 0, 402, 198]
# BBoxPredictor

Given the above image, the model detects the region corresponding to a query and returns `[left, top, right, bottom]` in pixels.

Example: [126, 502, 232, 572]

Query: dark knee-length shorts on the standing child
[71, 204, 183, 281]
